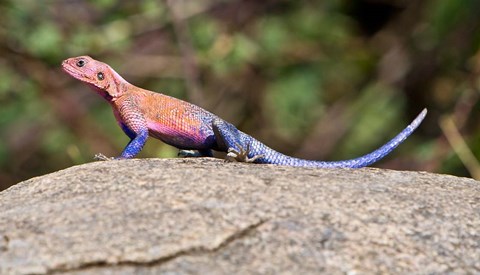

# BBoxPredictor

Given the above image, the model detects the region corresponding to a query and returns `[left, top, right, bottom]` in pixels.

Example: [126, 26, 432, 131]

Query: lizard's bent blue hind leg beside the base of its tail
[212, 118, 264, 163]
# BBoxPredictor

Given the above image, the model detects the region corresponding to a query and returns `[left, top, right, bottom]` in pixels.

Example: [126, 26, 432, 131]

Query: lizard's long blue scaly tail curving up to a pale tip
[222, 109, 427, 168]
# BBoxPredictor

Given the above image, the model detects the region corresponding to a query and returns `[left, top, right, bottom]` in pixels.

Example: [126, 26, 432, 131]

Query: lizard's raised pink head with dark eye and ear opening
[62, 56, 126, 101]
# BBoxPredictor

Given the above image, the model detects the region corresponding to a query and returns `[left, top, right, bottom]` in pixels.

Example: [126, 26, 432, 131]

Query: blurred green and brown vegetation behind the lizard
[0, 0, 480, 190]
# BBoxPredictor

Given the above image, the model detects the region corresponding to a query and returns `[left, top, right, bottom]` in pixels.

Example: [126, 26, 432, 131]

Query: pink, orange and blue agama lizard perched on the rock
[62, 56, 427, 168]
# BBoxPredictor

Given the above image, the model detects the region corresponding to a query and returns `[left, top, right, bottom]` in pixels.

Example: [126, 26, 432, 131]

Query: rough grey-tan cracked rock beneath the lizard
[0, 158, 480, 274]
